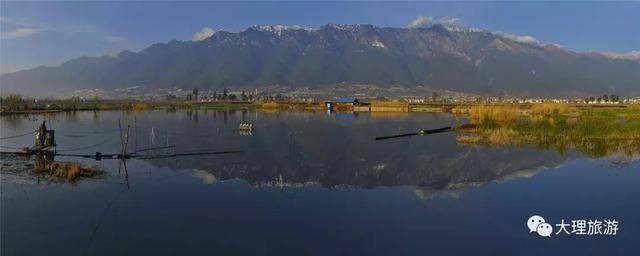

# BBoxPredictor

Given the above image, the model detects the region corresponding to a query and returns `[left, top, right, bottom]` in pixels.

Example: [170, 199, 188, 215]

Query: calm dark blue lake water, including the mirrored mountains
[0, 110, 640, 255]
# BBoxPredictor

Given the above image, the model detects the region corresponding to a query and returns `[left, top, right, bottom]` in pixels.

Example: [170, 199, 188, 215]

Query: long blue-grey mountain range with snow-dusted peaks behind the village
[0, 24, 640, 97]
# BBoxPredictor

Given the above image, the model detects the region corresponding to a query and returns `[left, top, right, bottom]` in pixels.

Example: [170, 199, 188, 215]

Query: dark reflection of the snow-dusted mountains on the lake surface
[3, 110, 636, 191]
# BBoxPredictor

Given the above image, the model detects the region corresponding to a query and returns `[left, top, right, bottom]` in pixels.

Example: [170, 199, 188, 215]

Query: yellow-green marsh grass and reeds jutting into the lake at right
[457, 104, 640, 157]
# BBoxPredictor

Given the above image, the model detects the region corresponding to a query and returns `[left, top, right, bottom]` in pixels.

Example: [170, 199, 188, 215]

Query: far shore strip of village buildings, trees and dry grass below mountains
[1, 85, 640, 110]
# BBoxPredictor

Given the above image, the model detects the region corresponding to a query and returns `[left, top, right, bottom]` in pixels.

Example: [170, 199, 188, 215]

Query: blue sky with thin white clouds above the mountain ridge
[0, 2, 640, 73]
